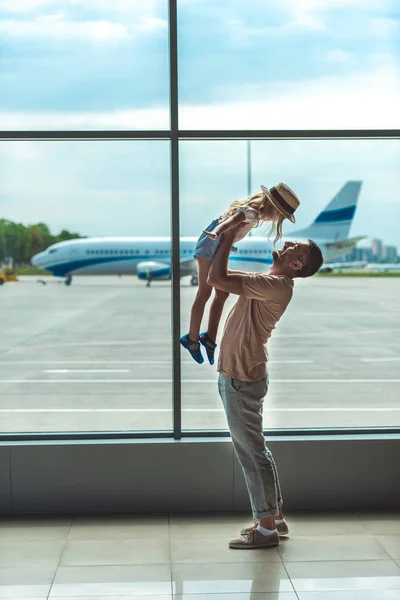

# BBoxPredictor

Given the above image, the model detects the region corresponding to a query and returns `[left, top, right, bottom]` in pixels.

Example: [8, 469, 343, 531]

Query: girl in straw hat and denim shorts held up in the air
[180, 183, 300, 365]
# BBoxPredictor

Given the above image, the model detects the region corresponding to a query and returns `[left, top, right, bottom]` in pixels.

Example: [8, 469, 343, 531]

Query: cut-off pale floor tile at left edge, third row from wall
[0, 567, 55, 600]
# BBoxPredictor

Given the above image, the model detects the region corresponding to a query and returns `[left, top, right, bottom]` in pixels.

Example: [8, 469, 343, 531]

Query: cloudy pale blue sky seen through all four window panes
[0, 0, 400, 248]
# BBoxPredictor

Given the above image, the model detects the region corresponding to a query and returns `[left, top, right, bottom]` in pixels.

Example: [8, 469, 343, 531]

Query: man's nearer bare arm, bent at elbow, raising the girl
[208, 229, 247, 296]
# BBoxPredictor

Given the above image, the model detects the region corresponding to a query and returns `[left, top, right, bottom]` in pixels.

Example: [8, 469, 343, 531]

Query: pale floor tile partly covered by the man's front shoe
[171, 536, 281, 564]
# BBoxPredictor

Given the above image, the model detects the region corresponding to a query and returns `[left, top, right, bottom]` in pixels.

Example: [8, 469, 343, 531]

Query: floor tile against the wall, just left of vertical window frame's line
[68, 515, 169, 541]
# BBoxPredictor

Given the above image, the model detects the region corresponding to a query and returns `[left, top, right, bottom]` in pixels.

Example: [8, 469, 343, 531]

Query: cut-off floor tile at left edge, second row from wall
[0, 541, 65, 567]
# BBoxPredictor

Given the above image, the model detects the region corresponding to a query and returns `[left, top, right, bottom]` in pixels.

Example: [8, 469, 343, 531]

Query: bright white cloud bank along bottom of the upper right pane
[180, 67, 400, 129]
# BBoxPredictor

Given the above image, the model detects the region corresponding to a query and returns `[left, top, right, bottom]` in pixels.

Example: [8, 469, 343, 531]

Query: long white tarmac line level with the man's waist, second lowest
[0, 379, 400, 384]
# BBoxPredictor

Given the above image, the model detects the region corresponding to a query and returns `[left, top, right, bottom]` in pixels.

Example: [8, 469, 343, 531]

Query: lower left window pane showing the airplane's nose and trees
[0, 141, 172, 433]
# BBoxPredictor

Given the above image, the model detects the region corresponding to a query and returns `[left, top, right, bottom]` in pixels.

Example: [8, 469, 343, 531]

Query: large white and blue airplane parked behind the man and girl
[31, 181, 365, 285]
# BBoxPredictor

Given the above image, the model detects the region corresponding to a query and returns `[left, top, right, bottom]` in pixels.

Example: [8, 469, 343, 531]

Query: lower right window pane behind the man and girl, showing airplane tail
[181, 140, 400, 430]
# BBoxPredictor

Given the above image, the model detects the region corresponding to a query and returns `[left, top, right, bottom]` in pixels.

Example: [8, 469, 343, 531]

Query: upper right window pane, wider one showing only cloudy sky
[178, 0, 400, 129]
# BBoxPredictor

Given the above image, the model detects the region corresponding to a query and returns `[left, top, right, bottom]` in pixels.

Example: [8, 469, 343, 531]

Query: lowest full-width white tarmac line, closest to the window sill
[0, 406, 400, 413]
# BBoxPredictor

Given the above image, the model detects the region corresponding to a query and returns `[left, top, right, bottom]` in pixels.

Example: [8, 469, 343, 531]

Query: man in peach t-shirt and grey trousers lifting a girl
[208, 230, 323, 549]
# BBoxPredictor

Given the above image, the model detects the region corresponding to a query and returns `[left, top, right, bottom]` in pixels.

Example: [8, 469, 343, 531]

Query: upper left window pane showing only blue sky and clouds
[0, 0, 169, 130]
